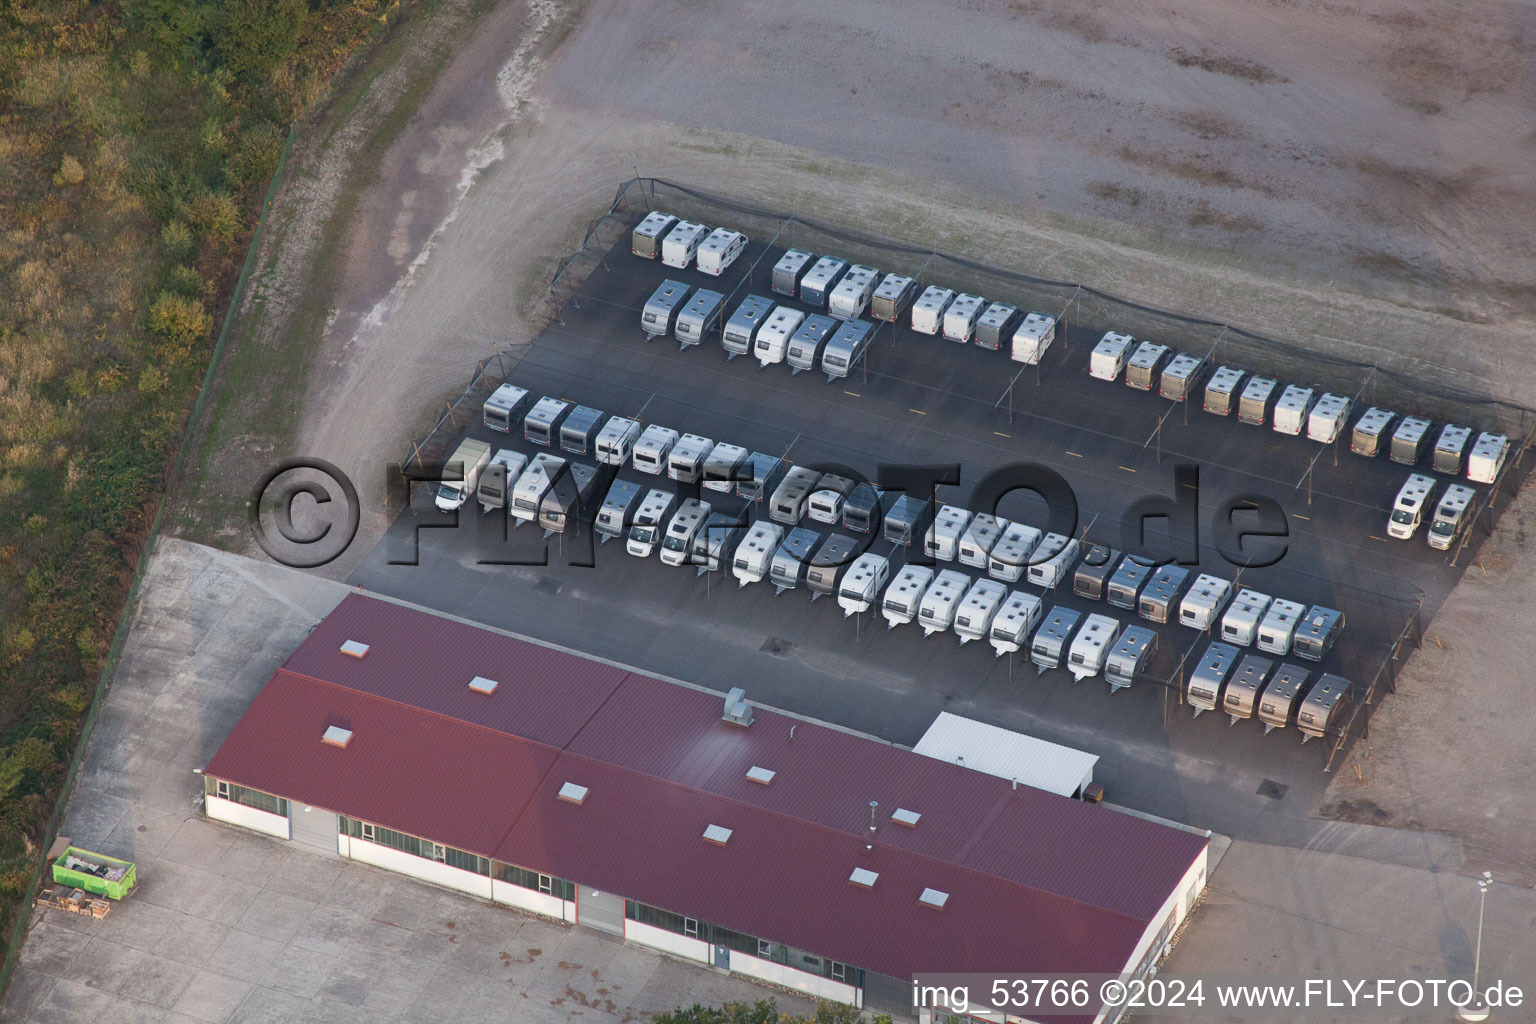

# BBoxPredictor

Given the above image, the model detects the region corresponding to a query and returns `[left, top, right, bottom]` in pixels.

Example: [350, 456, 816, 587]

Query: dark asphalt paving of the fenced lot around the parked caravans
[349, 224, 1511, 841]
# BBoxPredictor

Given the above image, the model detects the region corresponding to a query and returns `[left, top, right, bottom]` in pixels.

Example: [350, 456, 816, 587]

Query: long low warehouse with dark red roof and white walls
[204, 594, 1207, 1021]
